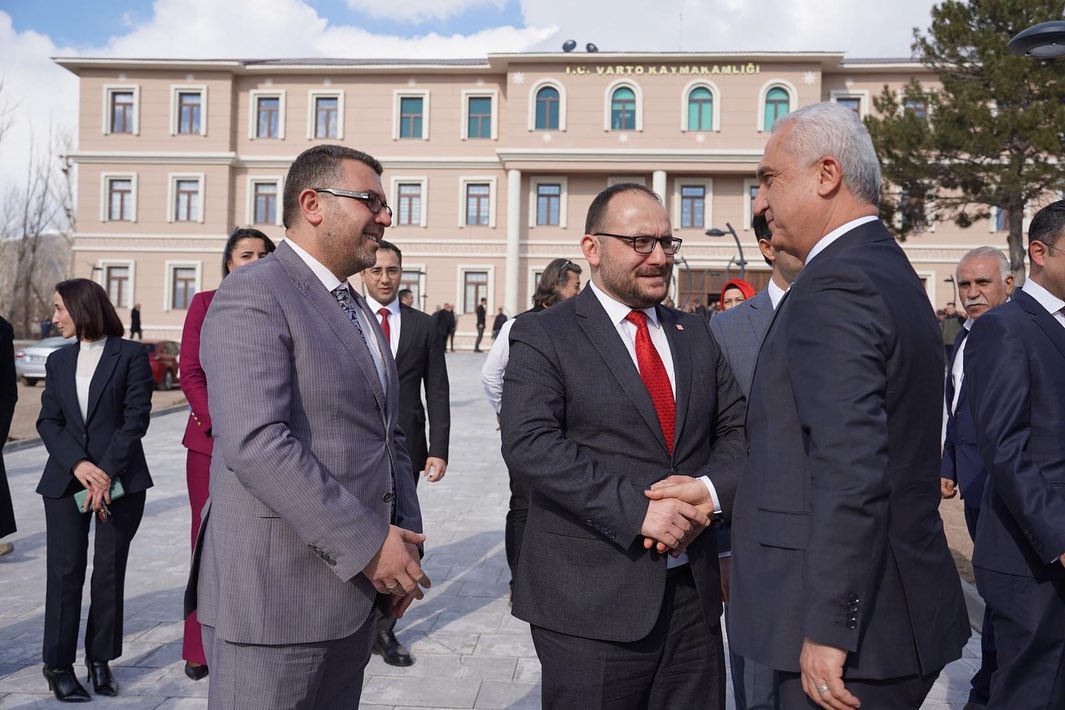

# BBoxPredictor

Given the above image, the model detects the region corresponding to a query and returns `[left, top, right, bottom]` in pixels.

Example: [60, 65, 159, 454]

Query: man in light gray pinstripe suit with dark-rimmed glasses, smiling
[186, 145, 429, 709]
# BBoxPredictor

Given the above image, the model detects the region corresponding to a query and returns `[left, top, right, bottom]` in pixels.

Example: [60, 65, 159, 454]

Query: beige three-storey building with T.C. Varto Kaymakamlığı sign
[58, 52, 1005, 347]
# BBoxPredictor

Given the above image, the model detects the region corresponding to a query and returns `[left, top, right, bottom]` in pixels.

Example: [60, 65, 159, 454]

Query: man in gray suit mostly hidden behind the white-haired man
[710, 215, 802, 710]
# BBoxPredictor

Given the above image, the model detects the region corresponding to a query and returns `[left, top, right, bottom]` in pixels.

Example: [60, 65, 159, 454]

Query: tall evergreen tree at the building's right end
[866, 0, 1065, 280]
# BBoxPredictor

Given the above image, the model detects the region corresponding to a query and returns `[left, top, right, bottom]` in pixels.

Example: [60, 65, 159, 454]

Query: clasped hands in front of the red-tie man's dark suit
[640, 476, 716, 557]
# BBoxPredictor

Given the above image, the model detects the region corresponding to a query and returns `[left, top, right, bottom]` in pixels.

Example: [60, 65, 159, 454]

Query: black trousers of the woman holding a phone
[43, 491, 146, 668]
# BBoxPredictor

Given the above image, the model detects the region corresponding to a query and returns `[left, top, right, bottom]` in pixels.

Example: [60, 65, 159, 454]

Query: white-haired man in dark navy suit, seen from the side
[651, 103, 969, 709]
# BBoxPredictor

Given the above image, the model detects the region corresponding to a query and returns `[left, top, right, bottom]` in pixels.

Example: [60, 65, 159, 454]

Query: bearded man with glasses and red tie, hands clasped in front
[501, 183, 743, 710]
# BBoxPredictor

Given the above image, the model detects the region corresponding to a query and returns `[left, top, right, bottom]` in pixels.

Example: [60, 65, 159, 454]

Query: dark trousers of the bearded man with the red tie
[533, 565, 725, 710]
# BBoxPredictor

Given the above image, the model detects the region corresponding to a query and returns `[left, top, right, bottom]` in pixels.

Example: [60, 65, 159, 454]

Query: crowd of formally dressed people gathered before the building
[0, 97, 1065, 710]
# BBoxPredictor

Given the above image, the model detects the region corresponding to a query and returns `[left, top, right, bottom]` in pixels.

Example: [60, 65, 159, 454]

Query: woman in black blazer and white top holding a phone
[37, 279, 153, 703]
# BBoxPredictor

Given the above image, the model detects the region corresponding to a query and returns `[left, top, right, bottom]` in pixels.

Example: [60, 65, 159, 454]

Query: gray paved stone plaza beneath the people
[0, 352, 979, 710]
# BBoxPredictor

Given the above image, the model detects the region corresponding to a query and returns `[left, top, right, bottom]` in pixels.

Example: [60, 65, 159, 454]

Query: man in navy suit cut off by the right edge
[965, 201, 1065, 708]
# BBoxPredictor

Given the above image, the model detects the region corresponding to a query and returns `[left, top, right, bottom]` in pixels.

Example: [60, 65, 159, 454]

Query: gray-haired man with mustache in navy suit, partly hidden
[939, 247, 1013, 708]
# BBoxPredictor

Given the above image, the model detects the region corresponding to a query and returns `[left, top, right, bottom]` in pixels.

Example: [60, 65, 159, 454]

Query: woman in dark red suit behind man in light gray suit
[179, 229, 274, 680]
